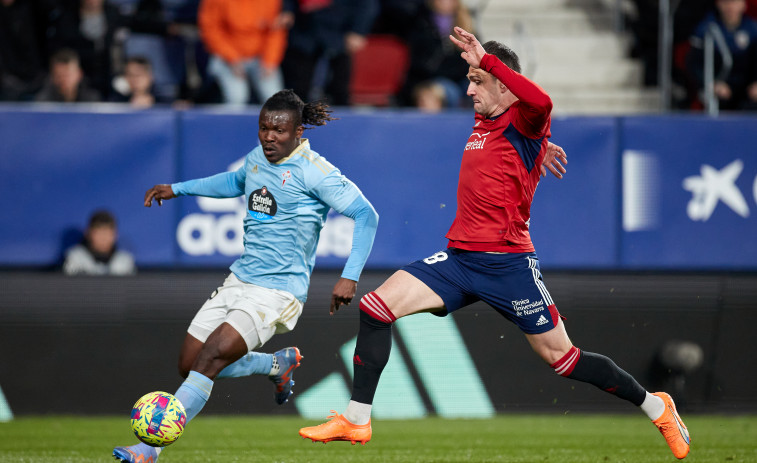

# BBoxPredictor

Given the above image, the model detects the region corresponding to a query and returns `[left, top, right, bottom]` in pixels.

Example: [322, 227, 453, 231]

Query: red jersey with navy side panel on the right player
[446, 54, 552, 252]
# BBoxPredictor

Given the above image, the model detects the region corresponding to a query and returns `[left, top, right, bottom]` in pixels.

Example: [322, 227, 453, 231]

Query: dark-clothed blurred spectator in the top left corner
[0, 0, 46, 101]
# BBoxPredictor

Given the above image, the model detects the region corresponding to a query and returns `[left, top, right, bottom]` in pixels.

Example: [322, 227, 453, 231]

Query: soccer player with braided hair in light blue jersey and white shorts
[113, 90, 378, 463]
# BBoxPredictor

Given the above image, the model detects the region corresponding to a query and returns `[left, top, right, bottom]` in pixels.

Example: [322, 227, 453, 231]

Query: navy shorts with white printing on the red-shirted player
[402, 248, 560, 334]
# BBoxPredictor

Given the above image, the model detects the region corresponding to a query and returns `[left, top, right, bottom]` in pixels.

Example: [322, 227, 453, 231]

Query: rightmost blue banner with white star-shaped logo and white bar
[621, 116, 757, 269]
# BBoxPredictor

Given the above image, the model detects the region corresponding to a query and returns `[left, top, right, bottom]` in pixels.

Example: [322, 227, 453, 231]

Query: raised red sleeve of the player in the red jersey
[480, 53, 552, 138]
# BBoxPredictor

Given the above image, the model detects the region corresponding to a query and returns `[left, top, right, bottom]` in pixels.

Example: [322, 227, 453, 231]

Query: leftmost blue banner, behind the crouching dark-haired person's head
[0, 108, 177, 266]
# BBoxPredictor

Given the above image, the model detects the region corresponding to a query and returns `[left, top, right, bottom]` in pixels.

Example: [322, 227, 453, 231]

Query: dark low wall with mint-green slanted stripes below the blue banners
[0, 270, 757, 417]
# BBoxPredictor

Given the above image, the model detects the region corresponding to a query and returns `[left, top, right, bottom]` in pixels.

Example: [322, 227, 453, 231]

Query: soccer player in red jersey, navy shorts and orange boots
[300, 27, 689, 458]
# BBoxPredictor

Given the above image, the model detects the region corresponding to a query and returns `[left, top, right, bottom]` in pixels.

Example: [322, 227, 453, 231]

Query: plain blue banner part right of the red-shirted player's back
[530, 117, 619, 268]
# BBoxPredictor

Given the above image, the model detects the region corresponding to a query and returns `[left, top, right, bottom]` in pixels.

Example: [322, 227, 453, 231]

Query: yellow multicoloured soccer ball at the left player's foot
[131, 391, 187, 447]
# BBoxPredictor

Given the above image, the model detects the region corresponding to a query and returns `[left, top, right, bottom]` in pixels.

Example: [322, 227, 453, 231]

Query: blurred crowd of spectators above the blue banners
[0, 0, 757, 112]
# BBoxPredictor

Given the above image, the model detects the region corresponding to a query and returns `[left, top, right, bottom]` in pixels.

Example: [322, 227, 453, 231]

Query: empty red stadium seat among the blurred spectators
[350, 35, 409, 106]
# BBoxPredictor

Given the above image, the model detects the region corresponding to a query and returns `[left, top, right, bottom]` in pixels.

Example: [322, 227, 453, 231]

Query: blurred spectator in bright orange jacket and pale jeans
[198, 0, 287, 105]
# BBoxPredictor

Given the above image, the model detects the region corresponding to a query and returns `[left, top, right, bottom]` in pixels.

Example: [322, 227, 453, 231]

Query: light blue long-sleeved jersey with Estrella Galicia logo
[171, 139, 378, 302]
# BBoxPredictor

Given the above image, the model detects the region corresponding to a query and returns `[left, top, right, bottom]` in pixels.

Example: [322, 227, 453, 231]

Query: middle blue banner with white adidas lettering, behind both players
[177, 111, 617, 268]
